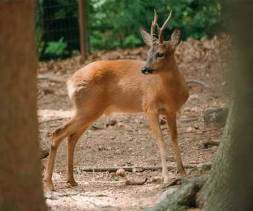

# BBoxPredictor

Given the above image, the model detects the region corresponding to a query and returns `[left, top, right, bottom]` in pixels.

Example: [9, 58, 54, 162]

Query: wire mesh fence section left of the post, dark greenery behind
[36, 0, 80, 59]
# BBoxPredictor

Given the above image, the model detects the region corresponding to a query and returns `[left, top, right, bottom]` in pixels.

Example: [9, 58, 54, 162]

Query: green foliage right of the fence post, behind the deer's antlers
[89, 0, 221, 49]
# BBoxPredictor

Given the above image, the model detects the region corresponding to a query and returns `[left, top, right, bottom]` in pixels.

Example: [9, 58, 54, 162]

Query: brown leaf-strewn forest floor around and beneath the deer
[38, 35, 229, 210]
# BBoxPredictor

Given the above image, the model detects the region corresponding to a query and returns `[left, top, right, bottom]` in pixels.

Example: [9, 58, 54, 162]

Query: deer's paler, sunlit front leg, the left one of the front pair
[147, 112, 169, 183]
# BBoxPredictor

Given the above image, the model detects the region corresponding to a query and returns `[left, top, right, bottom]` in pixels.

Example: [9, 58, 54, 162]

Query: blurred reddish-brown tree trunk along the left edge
[0, 0, 47, 211]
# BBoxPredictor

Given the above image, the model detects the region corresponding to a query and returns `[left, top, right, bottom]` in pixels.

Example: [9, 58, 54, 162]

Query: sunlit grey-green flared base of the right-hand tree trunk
[199, 108, 234, 210]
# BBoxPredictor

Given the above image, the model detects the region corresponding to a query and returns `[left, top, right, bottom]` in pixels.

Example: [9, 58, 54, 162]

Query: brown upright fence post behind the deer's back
[79, 0, 88, 64]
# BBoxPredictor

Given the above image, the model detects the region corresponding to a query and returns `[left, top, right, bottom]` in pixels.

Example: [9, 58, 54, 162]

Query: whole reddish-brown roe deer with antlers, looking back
[44, 10, 189, 190]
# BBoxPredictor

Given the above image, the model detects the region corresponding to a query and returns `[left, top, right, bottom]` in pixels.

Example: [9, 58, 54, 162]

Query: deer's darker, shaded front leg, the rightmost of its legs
[166, 114, 186, 176]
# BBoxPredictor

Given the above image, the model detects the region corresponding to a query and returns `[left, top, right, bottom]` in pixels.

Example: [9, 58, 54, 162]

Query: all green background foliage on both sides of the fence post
[36, 0, 222, 58]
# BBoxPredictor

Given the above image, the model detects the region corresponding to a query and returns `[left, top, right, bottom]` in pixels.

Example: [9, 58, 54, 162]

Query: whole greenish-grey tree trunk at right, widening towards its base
[200, 0, 253, 211]
